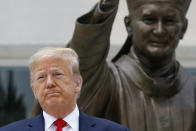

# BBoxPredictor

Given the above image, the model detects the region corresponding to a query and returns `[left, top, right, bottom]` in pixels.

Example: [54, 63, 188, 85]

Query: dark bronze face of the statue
[129, 2, 186, 59]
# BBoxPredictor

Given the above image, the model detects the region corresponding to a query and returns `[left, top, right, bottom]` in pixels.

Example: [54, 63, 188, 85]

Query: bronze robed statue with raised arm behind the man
[30, 0, 196, 131]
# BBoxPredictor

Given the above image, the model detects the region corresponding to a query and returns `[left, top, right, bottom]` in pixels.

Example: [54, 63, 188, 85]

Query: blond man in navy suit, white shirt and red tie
[0, 48, 128, 131]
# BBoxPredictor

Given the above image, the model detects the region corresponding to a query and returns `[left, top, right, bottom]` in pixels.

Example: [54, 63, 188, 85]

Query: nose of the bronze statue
[153, 21, 166, 36]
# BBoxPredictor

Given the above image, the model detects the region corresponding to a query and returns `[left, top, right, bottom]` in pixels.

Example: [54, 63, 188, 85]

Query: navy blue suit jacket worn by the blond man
[0, 111, 129, 131]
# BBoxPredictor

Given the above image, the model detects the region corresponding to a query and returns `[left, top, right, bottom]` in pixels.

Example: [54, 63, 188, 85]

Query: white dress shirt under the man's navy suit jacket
[43, 105, 79, 131]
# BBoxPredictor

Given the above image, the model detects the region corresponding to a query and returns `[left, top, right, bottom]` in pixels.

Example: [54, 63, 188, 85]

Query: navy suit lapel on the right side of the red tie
[79, 110, 98, 131]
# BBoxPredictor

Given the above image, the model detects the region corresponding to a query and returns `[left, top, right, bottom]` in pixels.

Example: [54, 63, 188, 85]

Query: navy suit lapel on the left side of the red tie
[28, 113, 44, 131]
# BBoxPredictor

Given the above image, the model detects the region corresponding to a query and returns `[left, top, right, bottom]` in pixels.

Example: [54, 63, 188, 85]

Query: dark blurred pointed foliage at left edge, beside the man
[0, 71, 26, 126]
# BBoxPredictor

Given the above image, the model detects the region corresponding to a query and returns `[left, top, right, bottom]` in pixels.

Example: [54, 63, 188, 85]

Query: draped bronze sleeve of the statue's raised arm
[69, 4, 120, 121]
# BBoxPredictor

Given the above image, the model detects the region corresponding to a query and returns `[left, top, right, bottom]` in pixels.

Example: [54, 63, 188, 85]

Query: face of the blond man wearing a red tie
[32, 57, 81, 111]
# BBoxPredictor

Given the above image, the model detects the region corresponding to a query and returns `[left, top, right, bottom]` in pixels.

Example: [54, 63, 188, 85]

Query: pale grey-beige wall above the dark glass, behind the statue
[0, 0, 196, 67]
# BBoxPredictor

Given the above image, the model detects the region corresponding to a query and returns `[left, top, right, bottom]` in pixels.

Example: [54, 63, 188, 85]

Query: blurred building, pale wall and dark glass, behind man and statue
[0, 0, 196, 126]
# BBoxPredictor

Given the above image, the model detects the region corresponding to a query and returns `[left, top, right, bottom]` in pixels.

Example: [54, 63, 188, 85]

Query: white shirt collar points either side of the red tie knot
[43, 105, 79, 131]
